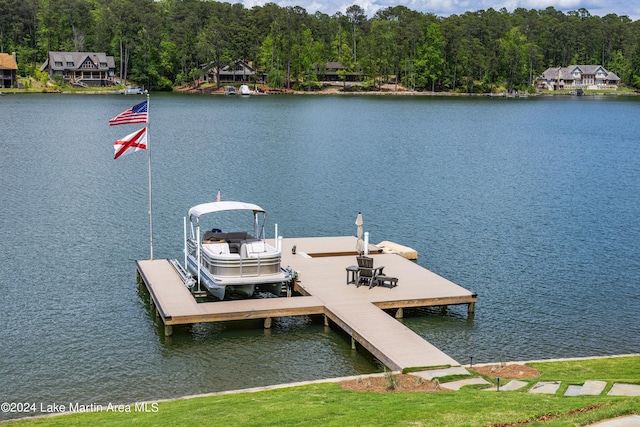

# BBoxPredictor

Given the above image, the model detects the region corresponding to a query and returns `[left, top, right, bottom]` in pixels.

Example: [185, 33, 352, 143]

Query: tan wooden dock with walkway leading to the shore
[136, 236, 476, 370]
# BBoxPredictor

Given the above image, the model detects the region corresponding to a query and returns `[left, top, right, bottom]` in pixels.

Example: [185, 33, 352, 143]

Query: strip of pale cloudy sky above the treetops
[238, 0, 640, 21]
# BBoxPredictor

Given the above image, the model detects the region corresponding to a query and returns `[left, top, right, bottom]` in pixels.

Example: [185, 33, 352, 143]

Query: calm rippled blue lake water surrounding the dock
[0, 94, 640, 420]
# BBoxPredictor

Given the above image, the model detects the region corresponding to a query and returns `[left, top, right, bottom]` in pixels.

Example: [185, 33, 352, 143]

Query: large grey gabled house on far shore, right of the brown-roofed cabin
[40, 52, 116, 87]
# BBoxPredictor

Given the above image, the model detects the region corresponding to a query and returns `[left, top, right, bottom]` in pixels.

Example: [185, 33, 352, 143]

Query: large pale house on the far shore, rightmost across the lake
[537, 65, 620, 90]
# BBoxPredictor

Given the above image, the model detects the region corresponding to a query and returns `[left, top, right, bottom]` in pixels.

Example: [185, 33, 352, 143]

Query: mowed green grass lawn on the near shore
[6, 356, 640, 427]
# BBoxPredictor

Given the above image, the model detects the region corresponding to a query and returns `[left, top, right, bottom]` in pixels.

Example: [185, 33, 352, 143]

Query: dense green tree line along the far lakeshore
[0, 0, 640, 92]
